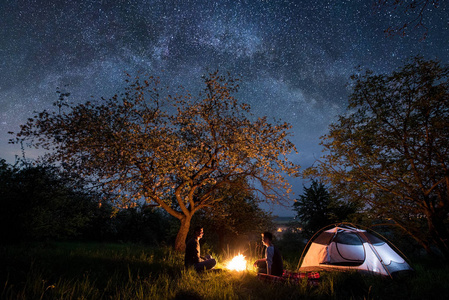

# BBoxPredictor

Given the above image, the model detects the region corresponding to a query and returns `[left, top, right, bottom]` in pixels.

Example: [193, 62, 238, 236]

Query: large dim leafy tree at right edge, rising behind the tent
[306, 57, 449, 258]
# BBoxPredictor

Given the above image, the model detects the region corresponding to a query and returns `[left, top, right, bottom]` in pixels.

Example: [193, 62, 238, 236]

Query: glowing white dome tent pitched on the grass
[299, 223, 412, 276]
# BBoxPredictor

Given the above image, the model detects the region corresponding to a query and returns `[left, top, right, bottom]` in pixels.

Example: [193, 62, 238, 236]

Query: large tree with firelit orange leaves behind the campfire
[15, 72, 299, 250]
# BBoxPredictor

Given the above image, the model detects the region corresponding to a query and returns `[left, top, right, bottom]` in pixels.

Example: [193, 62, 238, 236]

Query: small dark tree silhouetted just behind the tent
[293, 180, 357, 238]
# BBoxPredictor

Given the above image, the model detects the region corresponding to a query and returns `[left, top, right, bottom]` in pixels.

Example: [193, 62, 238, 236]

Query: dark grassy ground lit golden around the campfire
[0, 243, 449, 300]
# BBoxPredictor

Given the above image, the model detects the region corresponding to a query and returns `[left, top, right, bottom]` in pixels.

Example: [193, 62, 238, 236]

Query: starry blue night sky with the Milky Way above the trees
[0, 0, 449, 214]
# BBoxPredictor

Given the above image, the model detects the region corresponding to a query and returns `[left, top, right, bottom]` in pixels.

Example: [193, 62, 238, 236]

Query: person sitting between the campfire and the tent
[254, 231, 284, 276]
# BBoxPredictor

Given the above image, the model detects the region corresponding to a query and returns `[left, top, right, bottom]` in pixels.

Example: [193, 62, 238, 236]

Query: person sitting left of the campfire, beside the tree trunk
[184, 226, 217, 272]
